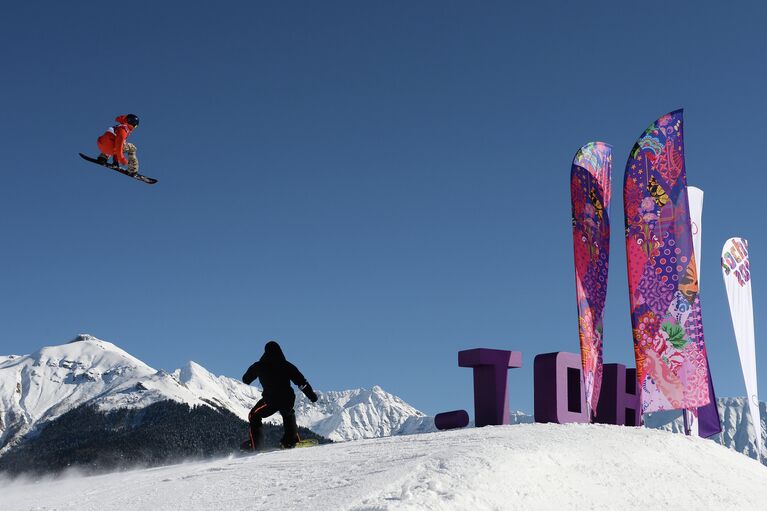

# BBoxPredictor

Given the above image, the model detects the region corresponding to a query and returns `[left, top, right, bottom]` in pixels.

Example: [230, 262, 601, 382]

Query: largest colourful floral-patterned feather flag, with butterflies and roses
[623, 110, 710, 413]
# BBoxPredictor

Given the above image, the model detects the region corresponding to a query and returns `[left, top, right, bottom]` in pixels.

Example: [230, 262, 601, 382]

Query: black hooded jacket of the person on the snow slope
[242, 341, 313, 407]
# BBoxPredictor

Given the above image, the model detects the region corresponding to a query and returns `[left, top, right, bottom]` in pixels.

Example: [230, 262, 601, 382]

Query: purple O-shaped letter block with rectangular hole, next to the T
[533, 351, 589, 424]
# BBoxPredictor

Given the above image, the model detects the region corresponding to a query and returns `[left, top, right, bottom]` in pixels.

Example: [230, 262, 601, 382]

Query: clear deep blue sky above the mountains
[0, 1, 767, 413]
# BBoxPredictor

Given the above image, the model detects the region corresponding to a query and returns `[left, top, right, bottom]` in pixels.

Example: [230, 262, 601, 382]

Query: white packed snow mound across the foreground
[0, 424, 767, 511]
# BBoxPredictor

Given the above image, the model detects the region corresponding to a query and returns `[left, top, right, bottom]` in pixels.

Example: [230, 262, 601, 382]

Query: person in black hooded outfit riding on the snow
[242, 341, 317, 450]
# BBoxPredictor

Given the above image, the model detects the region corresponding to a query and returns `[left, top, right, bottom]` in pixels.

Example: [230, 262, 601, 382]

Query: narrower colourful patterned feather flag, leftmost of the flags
[570, 142, 612, 415]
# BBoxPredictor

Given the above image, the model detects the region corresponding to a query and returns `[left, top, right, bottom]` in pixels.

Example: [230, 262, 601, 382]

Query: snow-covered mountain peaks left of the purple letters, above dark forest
[0, 334, 433, 455]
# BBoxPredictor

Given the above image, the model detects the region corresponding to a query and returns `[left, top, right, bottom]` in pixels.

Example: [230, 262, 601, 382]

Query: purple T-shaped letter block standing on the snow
[458, 348, 520, 428]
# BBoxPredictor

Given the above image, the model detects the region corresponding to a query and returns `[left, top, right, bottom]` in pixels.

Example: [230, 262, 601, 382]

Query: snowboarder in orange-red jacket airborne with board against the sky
[80, 114, 157, 184]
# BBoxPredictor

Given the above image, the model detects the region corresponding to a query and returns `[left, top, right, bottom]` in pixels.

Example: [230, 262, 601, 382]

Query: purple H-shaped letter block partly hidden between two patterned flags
[594, 364, 642, 426]
